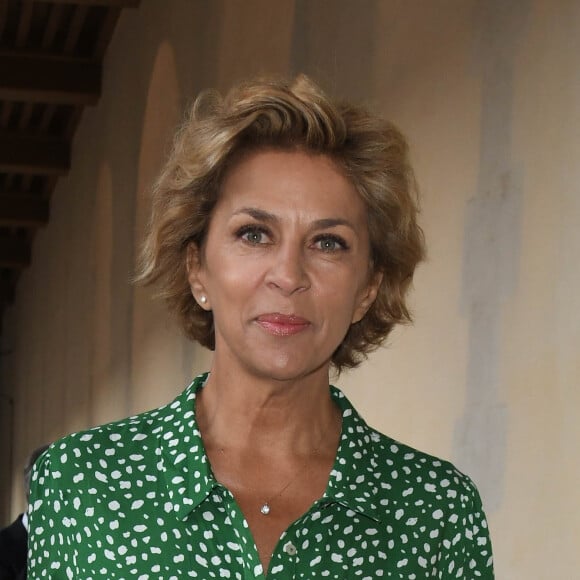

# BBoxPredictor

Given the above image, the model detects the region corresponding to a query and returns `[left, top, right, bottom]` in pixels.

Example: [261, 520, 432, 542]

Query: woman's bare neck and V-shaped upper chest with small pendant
[196, 364, 342, 570]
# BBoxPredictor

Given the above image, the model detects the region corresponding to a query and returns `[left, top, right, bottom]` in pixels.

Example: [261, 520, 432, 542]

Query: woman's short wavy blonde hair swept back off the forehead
[137, 75, 424, 372]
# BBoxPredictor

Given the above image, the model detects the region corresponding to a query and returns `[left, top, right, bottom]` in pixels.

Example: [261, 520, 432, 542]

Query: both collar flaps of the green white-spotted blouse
[154, 373, 380, 521]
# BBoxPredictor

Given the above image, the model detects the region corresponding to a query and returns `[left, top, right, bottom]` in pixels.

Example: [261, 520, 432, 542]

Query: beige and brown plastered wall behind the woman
[0, 0, 580, 580]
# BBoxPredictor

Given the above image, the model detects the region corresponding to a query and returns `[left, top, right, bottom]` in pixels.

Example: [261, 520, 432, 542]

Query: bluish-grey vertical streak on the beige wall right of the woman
[454, 0, 530, 512]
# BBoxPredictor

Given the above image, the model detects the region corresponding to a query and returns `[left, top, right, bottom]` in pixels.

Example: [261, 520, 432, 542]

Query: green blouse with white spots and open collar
[28, 375, 493, 580]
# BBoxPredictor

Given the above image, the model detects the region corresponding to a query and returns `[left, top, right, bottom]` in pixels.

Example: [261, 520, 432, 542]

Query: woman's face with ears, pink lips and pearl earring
[188, 150, 380, 380]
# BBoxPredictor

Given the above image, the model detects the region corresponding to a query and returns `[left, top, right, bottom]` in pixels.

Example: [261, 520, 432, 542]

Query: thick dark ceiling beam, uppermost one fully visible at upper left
[0, 52, 102, 105]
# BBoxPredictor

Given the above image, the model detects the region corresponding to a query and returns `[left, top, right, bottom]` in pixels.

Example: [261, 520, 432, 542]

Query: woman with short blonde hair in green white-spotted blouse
[30, 77, 493, 579]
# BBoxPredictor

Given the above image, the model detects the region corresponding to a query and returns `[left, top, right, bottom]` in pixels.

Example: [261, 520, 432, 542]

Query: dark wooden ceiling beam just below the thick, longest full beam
[0, 134, 70, 175]
